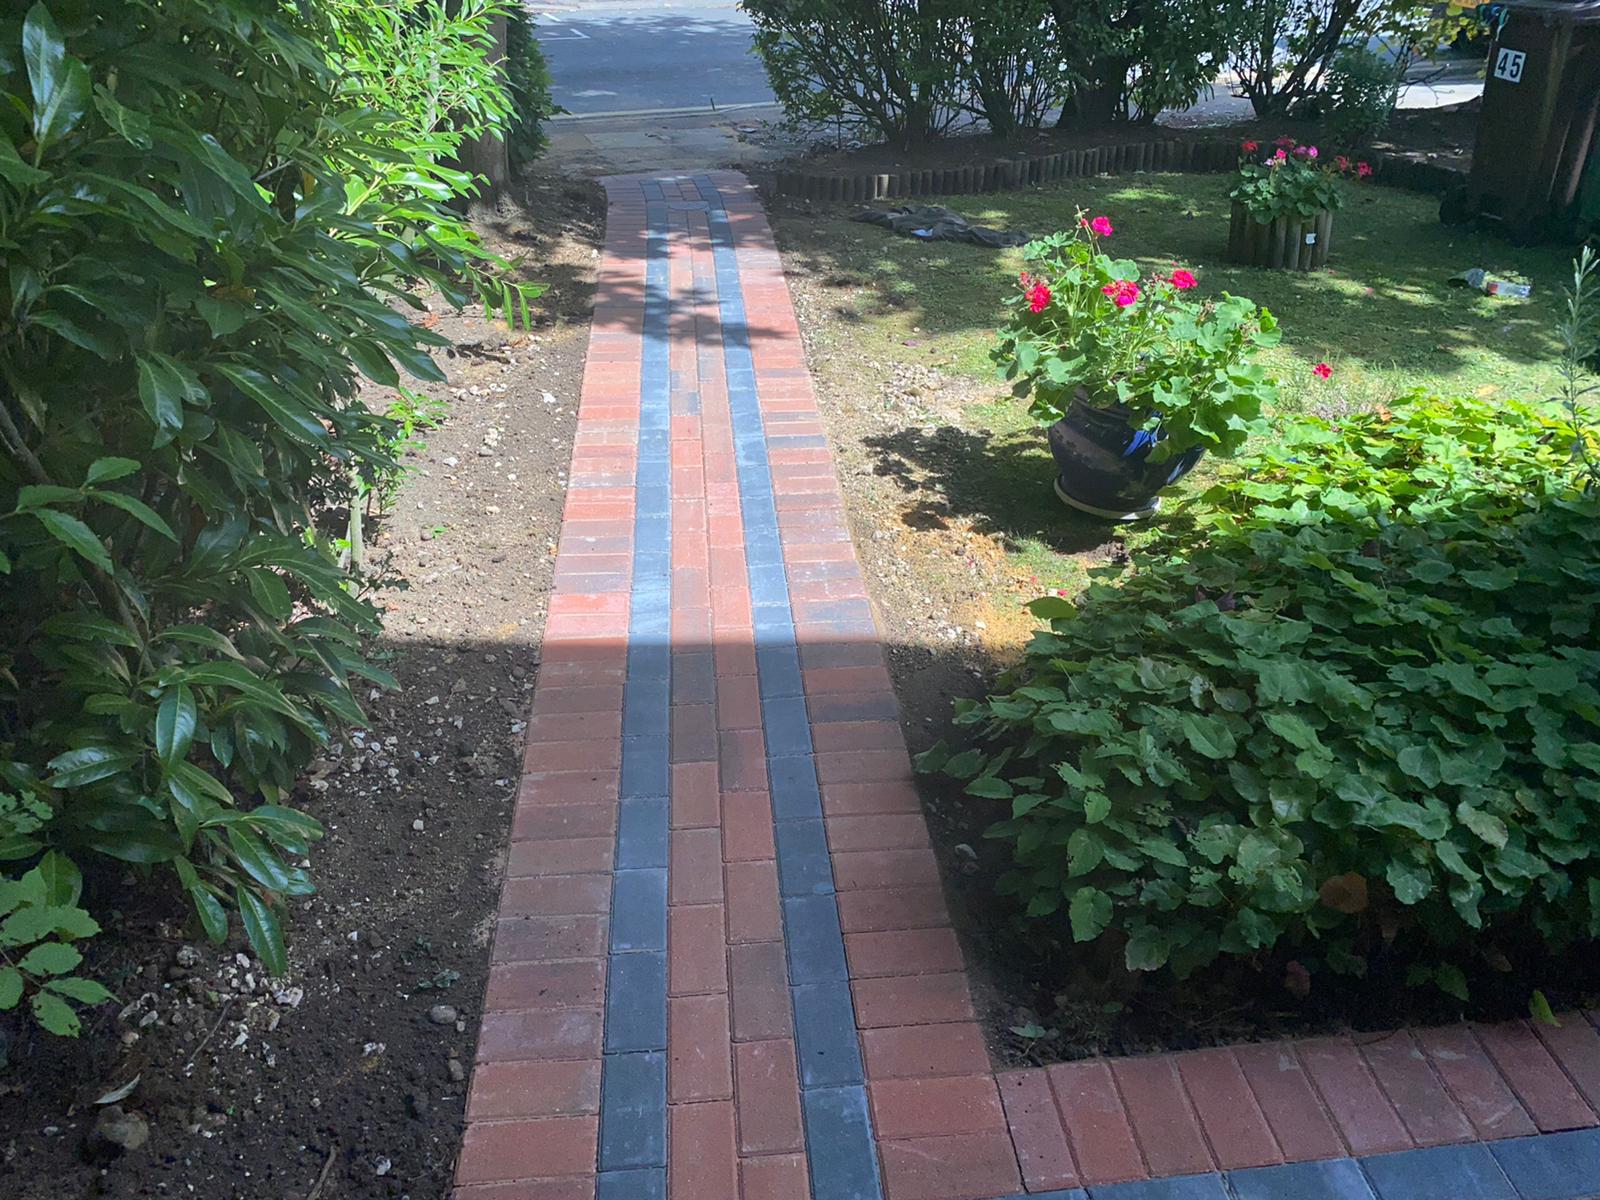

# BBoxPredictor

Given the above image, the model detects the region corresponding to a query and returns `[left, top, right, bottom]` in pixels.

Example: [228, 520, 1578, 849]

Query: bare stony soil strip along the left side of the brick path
[0, 181, 603, 1200]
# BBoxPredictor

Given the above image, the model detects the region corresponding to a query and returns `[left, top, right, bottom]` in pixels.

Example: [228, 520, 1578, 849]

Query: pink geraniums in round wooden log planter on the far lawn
[1227, 138, 1373, 270]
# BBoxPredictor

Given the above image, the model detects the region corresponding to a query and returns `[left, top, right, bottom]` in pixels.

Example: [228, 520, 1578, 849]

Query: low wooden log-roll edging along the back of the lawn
[766, 138, 1467, 203]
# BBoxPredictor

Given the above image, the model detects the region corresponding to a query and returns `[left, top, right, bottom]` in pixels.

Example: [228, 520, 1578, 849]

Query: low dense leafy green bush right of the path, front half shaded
[923, 395, 1600, 994]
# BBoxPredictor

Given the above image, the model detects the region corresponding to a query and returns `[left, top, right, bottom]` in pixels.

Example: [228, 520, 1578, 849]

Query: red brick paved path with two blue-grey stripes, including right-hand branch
[458, 173, 1600, 1200]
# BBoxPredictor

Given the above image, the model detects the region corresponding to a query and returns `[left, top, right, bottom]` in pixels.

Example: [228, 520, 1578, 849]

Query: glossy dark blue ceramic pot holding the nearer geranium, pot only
[1046, 398, 1205, 520]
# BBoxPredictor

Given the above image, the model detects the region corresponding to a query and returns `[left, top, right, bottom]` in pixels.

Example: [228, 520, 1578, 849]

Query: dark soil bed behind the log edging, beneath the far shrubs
[755, 101, 1478, 184]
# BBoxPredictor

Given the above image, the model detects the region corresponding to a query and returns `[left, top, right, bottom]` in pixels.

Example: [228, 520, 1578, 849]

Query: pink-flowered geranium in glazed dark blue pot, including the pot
[994, 213, 1278, 520]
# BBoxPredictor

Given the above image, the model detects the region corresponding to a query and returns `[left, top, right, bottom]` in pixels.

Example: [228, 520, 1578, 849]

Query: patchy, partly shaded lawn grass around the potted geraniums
[782, 174, 1571, 598]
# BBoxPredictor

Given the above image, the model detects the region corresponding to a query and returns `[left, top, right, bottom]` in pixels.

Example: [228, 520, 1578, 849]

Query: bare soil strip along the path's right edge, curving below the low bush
[773, 190, 1600, 1081]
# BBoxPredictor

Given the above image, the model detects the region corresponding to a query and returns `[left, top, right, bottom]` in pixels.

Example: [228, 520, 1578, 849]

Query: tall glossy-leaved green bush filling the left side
[0, 0, 515, 1032]
